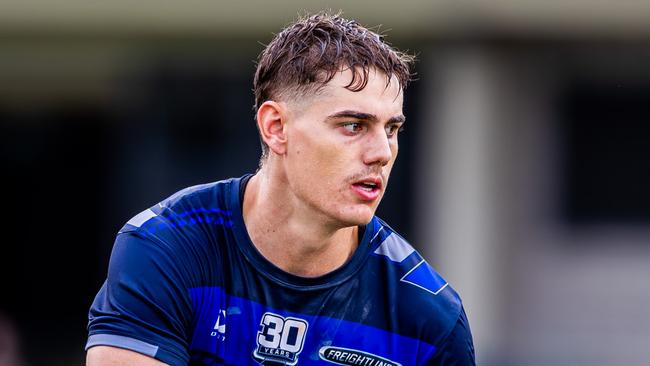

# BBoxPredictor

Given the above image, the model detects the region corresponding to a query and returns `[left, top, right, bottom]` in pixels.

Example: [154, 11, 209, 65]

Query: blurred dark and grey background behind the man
[0, 0, 650, 366]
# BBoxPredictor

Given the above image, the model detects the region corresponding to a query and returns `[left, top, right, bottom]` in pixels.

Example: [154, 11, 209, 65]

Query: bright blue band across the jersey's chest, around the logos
[190, 287, 436, 365]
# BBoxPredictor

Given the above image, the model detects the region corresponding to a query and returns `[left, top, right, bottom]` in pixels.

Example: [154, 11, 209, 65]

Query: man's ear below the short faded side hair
[257, 101, 287, 155]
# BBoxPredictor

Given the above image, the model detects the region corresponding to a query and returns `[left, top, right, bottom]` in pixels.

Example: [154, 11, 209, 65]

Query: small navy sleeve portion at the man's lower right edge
[429, 309, 476, 366]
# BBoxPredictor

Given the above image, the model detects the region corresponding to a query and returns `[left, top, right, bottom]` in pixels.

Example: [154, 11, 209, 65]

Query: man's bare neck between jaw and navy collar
[243, 167, 358, 277]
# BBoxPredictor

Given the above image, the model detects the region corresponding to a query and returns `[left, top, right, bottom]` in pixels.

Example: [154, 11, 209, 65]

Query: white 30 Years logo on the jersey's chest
[253, 312, 309, 365]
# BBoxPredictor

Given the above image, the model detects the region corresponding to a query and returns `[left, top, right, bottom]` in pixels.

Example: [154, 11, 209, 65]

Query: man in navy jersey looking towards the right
[86, 14, 474, 366]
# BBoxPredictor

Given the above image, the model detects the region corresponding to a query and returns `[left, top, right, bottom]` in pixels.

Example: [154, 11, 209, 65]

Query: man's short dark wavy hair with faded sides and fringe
[253, 12, 414, 160]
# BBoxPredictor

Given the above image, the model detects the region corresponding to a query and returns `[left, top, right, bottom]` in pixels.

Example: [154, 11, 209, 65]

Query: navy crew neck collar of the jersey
[226, 174, 380, 290]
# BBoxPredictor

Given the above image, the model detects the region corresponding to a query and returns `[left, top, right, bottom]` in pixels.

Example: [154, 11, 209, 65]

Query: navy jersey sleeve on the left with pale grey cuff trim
[86, 232, 192, 366]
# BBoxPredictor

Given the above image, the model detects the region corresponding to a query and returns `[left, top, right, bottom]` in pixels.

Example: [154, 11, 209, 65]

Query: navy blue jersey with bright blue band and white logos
[86, 177, 474, 366]
